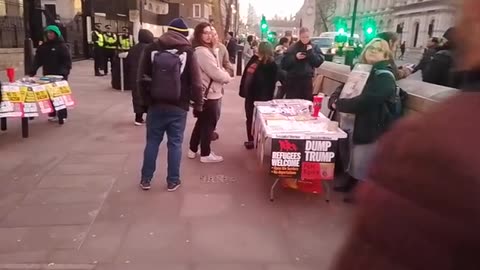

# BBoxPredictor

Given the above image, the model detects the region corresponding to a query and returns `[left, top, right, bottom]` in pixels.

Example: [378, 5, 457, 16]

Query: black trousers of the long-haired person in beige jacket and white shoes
[190, 99, 219, 157]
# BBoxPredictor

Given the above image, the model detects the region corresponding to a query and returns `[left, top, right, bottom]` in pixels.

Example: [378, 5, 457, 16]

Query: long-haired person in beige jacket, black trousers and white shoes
[188, 23, 231, 163]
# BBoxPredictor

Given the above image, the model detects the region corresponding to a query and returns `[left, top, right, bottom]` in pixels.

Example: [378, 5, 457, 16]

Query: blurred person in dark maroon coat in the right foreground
[331, 0, 480, 270]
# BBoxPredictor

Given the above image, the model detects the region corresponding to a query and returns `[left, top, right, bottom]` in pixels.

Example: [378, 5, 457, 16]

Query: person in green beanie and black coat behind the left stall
[29, 25, 72, 125]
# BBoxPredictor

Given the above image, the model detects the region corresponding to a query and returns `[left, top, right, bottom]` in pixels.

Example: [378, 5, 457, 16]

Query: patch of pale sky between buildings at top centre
[240, 0, 304, 18]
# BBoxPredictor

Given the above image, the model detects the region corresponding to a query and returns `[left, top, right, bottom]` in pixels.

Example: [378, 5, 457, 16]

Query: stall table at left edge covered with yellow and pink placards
[0, 76, 75, 138]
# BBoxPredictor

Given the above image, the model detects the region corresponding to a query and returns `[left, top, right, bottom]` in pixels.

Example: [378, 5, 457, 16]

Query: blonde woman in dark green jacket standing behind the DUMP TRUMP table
[334, 38, 397, 184]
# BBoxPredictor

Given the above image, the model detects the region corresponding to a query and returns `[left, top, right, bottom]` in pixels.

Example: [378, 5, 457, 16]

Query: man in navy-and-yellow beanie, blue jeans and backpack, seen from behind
[138, 18, 203, 192]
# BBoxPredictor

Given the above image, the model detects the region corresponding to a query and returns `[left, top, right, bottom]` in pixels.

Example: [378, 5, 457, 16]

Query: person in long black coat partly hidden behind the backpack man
[125, 29, 153, 126]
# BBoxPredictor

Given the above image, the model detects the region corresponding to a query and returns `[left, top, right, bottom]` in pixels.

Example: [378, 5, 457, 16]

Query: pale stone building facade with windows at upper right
[332, 0, 455, 48]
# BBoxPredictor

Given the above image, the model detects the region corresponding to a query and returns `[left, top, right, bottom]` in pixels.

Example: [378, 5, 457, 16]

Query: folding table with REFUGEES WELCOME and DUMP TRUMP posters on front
[253, 99, 347, 201]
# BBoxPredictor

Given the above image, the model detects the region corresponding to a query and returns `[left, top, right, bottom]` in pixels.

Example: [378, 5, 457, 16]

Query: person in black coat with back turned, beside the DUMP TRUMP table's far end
[240, 42, 278, 149]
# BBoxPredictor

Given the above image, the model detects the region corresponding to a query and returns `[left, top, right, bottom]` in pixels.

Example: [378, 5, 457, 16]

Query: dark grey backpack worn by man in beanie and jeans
[150, 50, 187, 102]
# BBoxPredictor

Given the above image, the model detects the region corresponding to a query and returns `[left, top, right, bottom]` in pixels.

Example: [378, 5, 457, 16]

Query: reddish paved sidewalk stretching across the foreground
[0, 61, 351, 270]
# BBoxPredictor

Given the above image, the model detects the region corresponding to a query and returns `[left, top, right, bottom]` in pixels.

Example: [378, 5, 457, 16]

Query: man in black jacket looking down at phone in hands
[281, 27, 324, 100]
